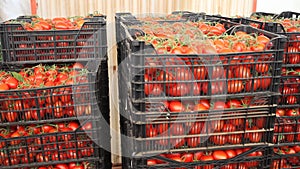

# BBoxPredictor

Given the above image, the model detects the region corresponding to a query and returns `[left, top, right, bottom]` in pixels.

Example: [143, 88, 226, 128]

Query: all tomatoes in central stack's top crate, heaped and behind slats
[135, 22, 274, 97]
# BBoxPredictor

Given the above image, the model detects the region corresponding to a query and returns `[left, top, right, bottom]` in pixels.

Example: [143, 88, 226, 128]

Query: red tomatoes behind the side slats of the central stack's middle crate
[146, 115, 267, 149]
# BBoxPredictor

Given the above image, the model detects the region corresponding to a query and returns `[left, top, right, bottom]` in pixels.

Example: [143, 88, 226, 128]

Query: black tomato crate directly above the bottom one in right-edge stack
[273, 115, 300, 146]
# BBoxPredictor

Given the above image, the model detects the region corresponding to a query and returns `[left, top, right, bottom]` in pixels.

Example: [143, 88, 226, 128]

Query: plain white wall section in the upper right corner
[256, 0, 300, 13]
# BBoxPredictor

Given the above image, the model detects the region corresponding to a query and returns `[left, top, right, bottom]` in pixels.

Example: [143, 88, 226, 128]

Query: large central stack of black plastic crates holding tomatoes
[117, 11, 286, 169]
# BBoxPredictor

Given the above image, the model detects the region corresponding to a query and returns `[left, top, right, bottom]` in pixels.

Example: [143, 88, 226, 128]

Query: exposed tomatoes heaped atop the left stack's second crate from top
[0, 63, 87, 91]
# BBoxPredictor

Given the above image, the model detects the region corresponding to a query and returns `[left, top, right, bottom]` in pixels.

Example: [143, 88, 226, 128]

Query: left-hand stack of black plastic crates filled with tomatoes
[0, 16, 111, 169]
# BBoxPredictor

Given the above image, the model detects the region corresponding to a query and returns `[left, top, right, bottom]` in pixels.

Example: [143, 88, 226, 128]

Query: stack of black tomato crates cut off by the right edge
[242, 11, 300, 169]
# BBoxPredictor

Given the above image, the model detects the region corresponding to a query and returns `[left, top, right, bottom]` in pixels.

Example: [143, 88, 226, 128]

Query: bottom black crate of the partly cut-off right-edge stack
[268, 146, 300, 169]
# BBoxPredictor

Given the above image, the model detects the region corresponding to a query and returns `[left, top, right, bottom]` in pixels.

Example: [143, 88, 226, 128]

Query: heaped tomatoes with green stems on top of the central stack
[133, 22, 270, 54]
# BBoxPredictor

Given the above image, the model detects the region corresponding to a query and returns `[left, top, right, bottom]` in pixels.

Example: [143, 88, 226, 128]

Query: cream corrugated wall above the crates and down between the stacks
[37, 0, 253, 164]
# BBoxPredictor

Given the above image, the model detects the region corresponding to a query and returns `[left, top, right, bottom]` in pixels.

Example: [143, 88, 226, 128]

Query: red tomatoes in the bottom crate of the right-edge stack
[271, 145, 300, 169]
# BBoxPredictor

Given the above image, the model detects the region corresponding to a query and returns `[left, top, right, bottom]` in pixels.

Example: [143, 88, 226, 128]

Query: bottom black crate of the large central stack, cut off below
[122, 147, 269, 169]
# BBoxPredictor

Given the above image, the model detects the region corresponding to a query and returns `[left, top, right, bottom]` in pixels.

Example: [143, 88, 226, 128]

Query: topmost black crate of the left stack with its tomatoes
[1, 17, 107, 63]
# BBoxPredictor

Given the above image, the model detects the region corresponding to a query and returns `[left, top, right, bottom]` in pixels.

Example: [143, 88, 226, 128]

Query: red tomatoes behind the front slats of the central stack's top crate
[144, 56, 272, 97]
